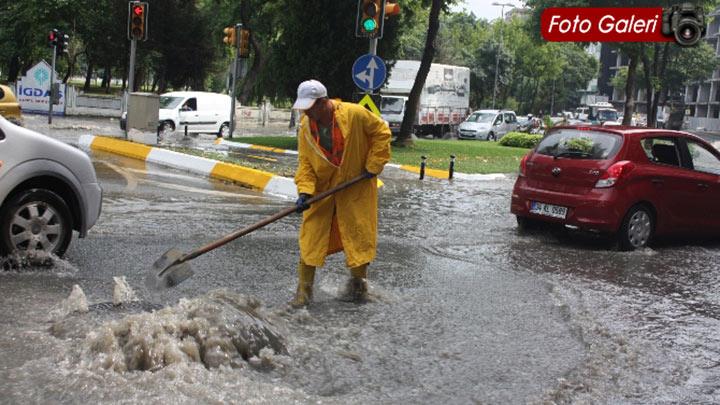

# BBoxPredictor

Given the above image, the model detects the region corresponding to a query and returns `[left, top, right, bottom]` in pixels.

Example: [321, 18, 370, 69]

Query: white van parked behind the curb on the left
[159, 91, 231, 137]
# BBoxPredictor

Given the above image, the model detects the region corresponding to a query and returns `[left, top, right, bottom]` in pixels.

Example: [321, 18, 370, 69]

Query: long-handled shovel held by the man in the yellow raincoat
[145, 175, 367, 290]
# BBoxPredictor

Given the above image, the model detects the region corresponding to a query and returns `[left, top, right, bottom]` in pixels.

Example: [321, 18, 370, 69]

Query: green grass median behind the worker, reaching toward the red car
[226, 136, 528, 174]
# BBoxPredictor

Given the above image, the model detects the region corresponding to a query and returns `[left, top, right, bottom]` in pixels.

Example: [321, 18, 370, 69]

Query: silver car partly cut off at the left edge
[0, 116, 102, 256]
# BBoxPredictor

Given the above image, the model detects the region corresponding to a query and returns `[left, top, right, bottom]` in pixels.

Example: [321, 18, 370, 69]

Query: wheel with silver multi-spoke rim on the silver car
[0, 189, 72, 256]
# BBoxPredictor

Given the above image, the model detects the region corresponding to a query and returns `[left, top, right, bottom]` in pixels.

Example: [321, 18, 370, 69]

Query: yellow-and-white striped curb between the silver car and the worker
[78, 135, 297, 198]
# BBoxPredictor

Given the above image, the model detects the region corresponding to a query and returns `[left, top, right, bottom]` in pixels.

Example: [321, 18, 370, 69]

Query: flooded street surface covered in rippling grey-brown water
[0, 113, 720, 404]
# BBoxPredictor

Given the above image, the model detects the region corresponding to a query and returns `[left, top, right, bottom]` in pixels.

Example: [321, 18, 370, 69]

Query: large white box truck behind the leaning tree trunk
[380, 60, 470, 138]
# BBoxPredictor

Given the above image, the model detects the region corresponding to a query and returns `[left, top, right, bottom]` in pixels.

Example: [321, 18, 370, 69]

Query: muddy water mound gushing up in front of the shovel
[83, 290, 287, 372]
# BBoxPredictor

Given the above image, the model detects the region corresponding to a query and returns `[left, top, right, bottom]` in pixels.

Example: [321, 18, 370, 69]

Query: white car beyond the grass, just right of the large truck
[458, 110, 518, 141]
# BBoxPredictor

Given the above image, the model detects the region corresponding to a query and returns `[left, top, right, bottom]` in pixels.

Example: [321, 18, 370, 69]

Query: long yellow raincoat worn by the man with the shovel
[295, 100, 390, 267]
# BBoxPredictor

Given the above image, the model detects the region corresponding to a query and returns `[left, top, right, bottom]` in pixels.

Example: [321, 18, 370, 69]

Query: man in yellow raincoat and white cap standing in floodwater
[290, 80, 390, 307]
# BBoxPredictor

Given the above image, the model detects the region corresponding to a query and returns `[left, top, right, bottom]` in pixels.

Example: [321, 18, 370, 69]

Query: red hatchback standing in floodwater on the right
[511, 126, 720, 250]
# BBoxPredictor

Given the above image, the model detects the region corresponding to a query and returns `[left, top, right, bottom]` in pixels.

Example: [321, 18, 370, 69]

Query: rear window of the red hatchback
[535, 129, 622, 160]
